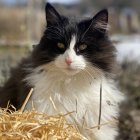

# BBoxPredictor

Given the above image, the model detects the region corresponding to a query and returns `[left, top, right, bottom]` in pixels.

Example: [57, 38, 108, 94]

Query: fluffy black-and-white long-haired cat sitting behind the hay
[0, 3, 123, 140]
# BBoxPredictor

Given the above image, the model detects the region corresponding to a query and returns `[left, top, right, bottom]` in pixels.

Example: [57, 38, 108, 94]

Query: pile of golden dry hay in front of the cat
[0, 89, 87, 140]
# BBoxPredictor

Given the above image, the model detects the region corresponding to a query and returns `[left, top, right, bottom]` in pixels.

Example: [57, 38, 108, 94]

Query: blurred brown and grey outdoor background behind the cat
[0, 0, 140, 140]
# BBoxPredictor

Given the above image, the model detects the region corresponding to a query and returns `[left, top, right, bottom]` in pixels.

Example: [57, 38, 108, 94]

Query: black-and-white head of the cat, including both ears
[33, 3, 115, 75]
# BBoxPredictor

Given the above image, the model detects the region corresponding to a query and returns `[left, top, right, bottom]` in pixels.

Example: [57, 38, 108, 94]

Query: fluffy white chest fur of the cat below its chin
[26, 66, 122, 140]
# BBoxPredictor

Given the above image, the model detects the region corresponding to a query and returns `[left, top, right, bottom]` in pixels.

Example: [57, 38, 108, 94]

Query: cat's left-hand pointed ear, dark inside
[45, 3, 61, 27]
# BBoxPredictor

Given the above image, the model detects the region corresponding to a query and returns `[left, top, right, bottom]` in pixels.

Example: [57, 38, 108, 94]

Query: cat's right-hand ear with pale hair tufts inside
[92, 9, 108, 32]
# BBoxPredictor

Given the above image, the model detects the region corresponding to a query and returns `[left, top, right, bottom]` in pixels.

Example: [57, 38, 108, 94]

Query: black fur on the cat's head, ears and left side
[0, 3, 116, 109]
